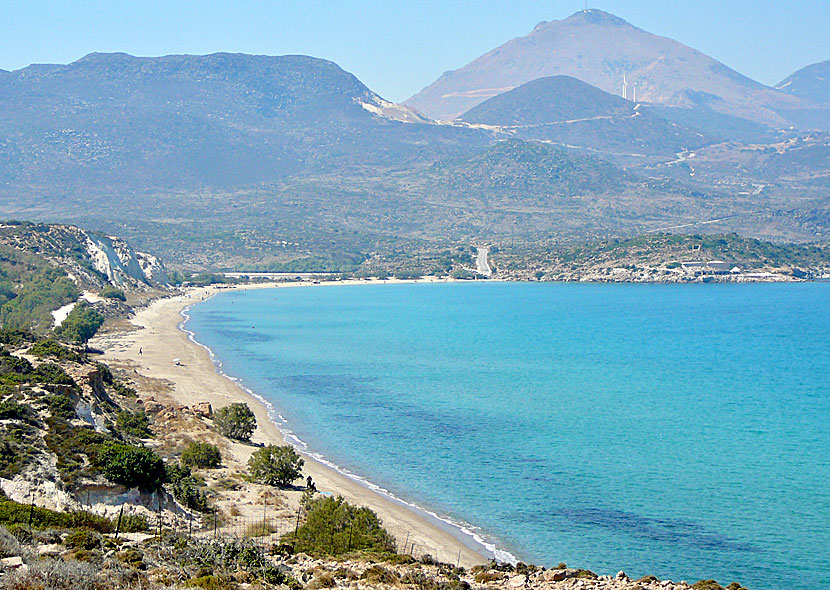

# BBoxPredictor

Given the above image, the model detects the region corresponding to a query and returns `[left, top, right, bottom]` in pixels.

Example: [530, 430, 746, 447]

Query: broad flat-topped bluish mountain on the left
[0, 53, 490, 191]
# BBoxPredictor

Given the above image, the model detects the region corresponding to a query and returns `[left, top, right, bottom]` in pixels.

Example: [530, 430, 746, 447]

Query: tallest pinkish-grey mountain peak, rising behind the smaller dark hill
[405, 9, 804, 126]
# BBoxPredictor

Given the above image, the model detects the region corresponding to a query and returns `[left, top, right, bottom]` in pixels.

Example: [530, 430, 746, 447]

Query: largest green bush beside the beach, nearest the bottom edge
[284, 496, 395, 555]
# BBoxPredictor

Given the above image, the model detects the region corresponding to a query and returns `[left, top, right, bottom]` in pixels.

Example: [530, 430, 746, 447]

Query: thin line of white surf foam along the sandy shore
[178, 295, 519, 564]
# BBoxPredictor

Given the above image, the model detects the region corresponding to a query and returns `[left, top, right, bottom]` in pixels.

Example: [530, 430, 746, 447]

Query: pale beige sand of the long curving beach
[91, 281, 490, 567]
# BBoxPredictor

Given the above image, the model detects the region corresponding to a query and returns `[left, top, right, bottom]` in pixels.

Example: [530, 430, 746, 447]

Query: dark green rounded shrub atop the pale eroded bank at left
[98, 444, 167, 492]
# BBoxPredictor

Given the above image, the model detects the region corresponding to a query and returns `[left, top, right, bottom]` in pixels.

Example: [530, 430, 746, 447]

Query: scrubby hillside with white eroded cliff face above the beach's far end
[0, 223, 169, 291]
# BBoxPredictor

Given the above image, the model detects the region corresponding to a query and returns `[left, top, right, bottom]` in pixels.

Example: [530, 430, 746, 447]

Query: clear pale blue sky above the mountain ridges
[0, 0, 830, 101]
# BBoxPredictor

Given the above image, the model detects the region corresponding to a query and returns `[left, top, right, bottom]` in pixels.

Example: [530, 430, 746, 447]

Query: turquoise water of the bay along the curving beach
[188, 283, 830, 590]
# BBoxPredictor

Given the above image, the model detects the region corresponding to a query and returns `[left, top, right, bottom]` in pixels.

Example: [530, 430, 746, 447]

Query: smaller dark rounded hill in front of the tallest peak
[461, 76, 707, 157]
